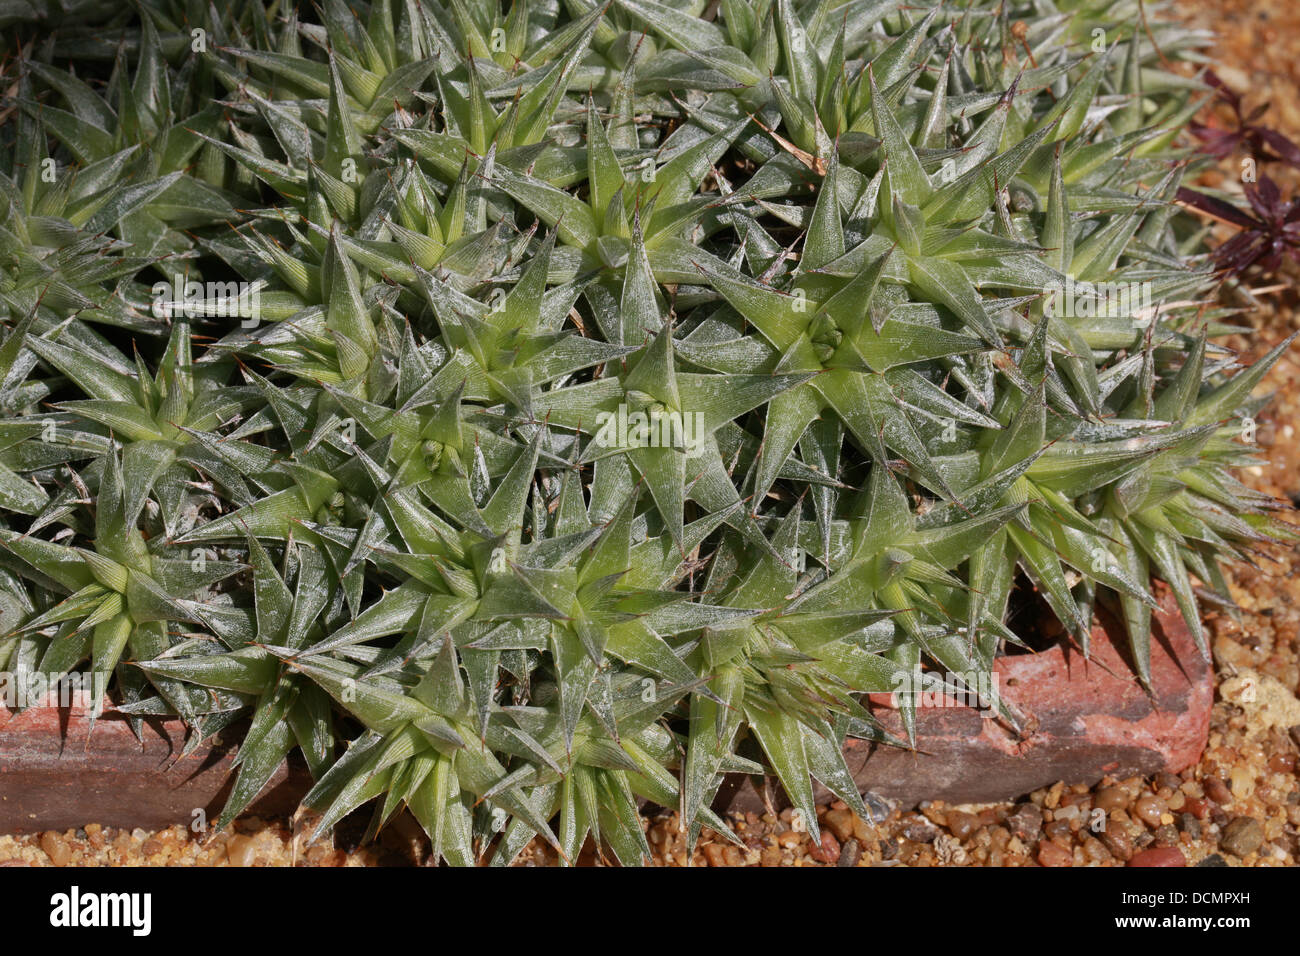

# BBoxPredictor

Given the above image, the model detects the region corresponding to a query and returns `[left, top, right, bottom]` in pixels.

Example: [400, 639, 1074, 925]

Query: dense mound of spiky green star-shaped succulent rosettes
[0, 0, 1287, 865]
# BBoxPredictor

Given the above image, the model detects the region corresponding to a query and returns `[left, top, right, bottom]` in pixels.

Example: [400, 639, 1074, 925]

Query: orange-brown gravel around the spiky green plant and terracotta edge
[0, 0, 1300, 866]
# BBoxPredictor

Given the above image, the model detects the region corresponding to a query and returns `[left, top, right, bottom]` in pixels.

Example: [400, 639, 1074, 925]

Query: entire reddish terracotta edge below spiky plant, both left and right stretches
[0, 598, 1214, 832]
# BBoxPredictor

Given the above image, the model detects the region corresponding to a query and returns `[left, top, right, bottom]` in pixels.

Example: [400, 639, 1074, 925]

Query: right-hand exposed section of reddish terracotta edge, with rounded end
[719, 594, 1214, 812]
